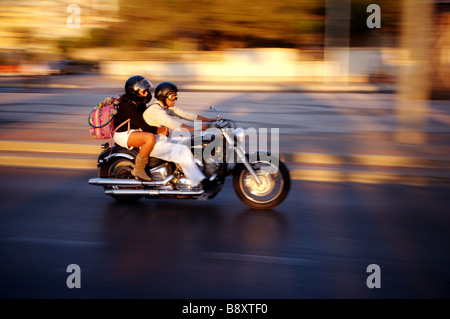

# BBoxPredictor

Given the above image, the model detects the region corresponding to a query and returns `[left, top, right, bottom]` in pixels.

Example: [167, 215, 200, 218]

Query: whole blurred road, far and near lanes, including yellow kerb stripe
[0, 77, 450, 298]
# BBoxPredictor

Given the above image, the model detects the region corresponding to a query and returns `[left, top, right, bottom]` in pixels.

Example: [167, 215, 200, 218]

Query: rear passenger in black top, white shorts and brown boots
[113, 75, 168, 181]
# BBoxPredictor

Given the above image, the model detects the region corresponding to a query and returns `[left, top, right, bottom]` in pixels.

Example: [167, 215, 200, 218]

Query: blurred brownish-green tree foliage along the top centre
[111, 0, 324, 50]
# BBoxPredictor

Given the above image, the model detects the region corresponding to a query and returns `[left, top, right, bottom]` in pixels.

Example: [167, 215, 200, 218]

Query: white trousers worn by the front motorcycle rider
[150, 134, 205, 186]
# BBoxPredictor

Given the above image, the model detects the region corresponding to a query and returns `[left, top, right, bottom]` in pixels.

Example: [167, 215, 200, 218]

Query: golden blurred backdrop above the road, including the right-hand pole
[0, 0, 450, 143]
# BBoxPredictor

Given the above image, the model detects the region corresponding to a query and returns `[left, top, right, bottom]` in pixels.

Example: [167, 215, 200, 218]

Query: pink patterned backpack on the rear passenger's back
[89, 97, 130, 140]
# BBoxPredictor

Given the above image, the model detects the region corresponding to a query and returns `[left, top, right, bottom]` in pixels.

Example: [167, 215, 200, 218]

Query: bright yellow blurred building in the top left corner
[0, 0, 119, 54]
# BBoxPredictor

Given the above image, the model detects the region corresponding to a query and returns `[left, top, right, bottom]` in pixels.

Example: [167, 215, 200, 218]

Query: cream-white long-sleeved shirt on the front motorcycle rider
[143, 103, 197, 130]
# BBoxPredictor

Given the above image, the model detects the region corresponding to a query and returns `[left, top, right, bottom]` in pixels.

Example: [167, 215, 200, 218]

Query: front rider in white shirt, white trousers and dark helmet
[143, 82, 218, 191]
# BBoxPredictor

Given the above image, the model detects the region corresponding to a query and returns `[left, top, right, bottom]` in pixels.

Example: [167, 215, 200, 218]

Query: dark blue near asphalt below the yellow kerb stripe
[0, 168, 450, 300]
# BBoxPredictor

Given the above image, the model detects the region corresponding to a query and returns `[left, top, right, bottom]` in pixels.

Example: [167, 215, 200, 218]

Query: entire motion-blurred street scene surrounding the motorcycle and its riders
[0, 0, 450, 302]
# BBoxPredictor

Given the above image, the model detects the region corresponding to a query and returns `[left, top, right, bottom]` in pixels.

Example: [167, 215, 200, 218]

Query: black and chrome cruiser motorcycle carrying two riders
[89, 106, 291, 210]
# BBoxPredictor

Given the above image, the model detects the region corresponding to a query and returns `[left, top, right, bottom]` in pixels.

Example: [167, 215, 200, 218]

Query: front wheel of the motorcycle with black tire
[233, 157, 291, 210]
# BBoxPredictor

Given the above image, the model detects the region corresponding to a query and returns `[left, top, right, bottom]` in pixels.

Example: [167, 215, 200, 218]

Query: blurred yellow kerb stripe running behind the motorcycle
[0, 141, 450, 186]
